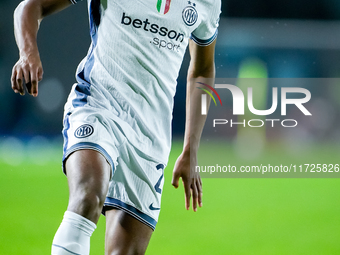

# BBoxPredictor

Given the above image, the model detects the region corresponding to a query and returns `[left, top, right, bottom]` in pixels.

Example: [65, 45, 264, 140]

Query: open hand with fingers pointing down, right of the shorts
[172, 152, 202, 212]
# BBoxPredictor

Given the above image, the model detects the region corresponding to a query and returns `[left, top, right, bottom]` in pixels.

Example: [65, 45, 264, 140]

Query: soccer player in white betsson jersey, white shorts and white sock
[12, 0, 221, 255]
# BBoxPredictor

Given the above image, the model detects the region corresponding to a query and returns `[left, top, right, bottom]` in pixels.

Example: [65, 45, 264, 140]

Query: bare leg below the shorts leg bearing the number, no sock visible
[105, 209, 153, 255]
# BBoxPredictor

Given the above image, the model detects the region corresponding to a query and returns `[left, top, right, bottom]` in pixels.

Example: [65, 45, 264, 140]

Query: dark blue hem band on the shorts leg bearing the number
[103, 197, 157, 230]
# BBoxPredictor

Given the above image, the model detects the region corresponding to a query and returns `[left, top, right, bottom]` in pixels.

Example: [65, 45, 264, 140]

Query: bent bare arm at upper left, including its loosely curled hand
[11, 0, 71, 96]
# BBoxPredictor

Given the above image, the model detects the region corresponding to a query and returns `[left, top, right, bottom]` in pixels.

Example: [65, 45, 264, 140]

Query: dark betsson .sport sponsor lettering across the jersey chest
[121, 12, 184, 52]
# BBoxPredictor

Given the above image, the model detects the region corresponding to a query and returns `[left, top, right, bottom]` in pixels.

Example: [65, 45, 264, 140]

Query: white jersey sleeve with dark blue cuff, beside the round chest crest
[190, 0, 221, 46]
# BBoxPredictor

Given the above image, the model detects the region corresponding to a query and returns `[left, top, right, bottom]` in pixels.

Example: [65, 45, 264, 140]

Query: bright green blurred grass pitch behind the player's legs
[0, 141, 340, 255]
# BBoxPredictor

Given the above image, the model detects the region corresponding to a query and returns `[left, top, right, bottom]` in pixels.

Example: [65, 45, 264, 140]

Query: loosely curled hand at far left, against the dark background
[11, 52, 43, 97]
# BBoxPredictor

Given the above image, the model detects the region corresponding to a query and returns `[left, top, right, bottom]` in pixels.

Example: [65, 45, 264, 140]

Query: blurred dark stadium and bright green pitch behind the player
[0, 0, 340, 255]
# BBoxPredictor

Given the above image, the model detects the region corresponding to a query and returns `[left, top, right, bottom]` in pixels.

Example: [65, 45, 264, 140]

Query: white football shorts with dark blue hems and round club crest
[62, 84, 165, 229]
